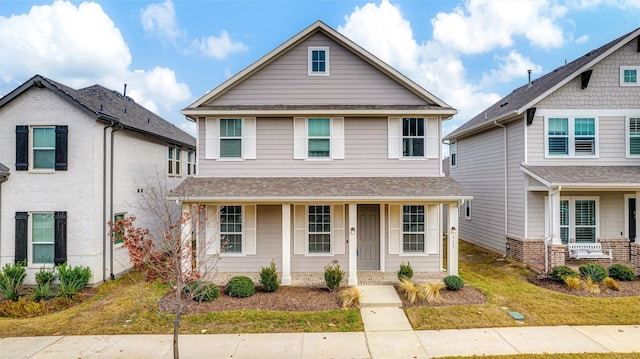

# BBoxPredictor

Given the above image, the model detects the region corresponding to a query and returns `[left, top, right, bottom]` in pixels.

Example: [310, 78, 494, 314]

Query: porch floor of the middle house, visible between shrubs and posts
[212, 271, 447, 287]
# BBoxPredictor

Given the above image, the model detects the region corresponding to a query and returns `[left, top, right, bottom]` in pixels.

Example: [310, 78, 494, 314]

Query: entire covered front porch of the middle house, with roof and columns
[172, 177, 470, 285]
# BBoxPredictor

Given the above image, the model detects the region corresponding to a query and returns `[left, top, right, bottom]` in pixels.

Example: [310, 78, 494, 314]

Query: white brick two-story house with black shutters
[0, 75, 196, 284]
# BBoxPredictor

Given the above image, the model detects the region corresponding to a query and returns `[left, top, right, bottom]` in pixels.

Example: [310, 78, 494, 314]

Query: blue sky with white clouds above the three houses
[0, 0, 640, 138]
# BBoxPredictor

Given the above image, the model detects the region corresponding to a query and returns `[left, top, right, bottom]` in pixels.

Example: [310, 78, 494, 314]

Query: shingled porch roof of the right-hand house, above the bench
[520, 165, 640, 190]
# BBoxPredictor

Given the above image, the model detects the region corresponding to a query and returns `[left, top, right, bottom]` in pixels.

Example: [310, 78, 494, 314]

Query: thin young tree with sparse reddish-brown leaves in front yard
[109, 174, 221, 359]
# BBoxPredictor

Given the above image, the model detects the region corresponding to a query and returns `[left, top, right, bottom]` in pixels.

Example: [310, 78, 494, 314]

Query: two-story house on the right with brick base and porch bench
[445, 29, 640, 270]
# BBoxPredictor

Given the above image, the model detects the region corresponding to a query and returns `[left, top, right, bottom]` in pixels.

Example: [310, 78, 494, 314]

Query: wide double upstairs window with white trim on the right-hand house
[546, 117, 598, 157]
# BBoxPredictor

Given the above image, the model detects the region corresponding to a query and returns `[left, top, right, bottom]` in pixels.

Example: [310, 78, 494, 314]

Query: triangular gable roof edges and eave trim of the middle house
[181, 20, 456, 117]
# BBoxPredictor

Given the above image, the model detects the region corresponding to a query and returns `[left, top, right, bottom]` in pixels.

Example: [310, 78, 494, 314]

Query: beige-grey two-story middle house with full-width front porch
[171, 21, 470, 285]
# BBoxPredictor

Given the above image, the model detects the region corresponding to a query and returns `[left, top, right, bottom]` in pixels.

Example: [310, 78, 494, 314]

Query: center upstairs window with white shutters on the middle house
[293, 117, 344, 160]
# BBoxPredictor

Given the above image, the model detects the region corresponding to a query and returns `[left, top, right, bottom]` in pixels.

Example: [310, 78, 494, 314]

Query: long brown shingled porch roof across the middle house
[169, 177, 472, 202]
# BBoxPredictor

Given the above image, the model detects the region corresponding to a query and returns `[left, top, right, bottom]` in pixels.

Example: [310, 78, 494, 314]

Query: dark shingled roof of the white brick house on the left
[0, 75, 196, 148]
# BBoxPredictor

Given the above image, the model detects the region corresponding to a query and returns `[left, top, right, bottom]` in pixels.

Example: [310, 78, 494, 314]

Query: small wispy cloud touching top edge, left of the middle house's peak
[142, 0, 183, 44]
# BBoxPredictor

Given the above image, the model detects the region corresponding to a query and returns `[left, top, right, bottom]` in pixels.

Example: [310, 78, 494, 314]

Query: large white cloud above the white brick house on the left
[0, 0, 191, 125]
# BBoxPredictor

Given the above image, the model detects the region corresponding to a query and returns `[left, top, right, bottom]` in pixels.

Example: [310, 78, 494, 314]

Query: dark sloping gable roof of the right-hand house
[444, 28, 640, 140]
